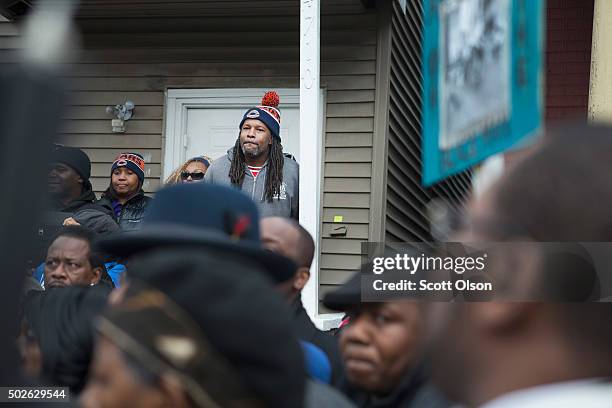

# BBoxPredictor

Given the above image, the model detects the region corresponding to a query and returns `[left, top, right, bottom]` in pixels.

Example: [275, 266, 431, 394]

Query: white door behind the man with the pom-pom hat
[185, 103, 300, 159]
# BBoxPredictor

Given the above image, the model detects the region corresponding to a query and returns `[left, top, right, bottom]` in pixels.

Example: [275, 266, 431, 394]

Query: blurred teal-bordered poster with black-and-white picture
[423, 0, 545, 185]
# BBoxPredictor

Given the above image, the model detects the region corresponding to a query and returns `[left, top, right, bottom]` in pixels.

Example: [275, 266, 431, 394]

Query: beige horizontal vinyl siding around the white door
[0, 0, 377, 306]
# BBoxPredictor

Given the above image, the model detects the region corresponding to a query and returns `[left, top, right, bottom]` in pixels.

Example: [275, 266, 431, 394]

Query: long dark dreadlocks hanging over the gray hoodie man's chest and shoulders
[228, 136, 285, 202]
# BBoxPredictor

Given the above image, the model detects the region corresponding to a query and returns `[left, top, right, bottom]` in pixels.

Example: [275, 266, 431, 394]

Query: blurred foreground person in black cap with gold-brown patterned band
[81, 248, 304, 408]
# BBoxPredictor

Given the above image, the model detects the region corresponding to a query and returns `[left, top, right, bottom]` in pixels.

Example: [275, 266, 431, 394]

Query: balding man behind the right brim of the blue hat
[260, 217, 342, 384]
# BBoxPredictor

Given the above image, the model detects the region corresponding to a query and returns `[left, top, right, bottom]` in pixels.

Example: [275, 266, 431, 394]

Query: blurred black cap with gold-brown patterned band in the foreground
[98, 248, 305, 408]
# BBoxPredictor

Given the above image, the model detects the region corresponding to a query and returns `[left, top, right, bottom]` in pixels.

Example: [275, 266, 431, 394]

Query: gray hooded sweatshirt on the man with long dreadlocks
[204, 147, 300, 220]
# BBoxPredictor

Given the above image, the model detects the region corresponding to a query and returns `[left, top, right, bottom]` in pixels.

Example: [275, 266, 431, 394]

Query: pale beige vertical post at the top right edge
[589, 0, 612, 124]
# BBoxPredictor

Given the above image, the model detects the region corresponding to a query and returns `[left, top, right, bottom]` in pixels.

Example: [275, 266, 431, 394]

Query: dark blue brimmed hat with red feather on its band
[98, 183, 297, 283]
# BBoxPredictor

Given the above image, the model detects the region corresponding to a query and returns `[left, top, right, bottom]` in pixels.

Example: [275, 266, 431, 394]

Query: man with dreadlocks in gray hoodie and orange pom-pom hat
[205, 92, 300, 220]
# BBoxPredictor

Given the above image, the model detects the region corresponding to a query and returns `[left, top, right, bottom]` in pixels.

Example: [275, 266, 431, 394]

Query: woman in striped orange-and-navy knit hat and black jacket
[98, 153, 152, 231]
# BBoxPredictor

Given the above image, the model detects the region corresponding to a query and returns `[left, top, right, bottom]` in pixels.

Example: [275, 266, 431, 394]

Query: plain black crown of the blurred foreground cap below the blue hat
[124, 247, 305, 408]
